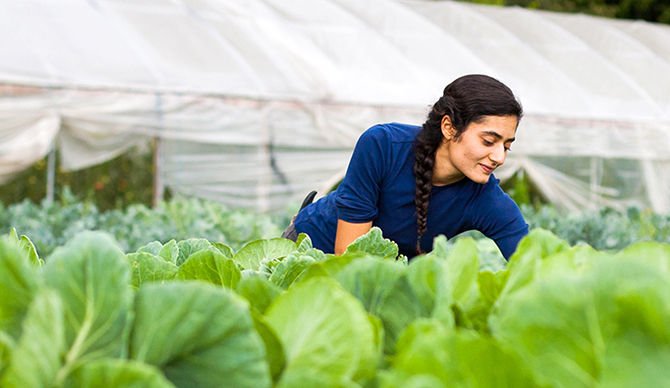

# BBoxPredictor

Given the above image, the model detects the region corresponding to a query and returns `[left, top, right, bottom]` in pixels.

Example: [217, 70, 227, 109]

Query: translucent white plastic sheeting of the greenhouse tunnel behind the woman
[0, 0, 670, 212]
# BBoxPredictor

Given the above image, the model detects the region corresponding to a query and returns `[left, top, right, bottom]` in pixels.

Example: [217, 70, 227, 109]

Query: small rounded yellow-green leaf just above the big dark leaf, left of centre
[177, 250, 242, 289]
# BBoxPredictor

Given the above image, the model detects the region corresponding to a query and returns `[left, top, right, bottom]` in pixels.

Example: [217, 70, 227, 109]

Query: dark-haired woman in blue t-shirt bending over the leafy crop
[284, 75, 528, 259]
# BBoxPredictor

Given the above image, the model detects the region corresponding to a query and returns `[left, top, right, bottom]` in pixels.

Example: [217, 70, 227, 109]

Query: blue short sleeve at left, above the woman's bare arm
[335, 125, 390, 223]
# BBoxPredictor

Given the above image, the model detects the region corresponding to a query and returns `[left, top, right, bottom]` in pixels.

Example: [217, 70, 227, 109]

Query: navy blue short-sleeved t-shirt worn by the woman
[295, 123, 528, 258]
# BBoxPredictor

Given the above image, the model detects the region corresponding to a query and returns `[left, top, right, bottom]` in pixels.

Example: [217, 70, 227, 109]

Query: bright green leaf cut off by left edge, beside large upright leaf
[0, 236, 39, 339]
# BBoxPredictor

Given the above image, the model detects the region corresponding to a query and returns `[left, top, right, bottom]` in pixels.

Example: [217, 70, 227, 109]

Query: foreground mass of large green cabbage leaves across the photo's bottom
[0, 224, 670, 388]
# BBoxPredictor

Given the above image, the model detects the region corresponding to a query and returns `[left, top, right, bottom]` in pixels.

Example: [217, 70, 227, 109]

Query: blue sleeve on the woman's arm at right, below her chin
[477, 184, 528, 260]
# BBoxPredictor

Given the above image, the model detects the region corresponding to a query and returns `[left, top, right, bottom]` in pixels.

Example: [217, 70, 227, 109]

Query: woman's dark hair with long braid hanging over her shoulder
[414, 74, 523, 255]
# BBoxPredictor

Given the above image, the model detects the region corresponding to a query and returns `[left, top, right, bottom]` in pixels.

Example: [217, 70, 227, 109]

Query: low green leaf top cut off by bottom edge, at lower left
[67, 358, 174, 388]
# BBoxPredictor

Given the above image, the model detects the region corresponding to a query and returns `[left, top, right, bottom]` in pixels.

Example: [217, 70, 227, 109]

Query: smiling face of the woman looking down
[435, 116, 518, 184]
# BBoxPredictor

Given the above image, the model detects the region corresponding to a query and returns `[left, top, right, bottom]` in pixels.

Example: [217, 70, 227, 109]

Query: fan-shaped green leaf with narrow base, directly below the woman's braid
[335, 258, 421, 354]
